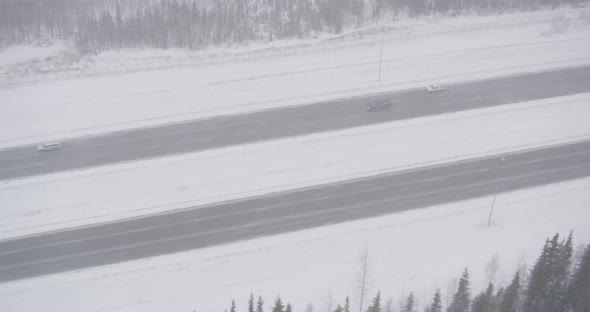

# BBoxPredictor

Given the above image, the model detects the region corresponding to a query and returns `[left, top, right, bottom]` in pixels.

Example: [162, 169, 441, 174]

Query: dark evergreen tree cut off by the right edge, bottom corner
[567, 245, 590, 312]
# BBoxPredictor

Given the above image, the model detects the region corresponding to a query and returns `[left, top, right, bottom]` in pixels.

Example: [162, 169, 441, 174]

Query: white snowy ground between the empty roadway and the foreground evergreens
[0, 179, 590, 312]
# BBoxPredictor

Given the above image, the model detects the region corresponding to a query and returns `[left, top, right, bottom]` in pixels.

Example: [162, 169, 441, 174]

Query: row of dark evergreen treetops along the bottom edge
[226, 234, 590, 312]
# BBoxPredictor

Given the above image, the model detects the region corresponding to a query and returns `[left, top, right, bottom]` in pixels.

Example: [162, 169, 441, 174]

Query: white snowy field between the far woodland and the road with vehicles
[0, 9, 590, 148]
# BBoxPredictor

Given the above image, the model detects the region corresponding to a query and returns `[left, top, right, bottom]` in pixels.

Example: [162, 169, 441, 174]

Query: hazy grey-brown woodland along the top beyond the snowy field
[0, 0, 583, 52]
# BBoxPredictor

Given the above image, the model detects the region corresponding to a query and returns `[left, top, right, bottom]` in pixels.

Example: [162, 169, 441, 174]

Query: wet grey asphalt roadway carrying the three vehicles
[0, 67, 590, 180]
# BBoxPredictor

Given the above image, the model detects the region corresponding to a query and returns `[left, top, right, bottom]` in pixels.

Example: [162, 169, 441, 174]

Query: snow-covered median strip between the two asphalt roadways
[0, 93, 590, 238]
